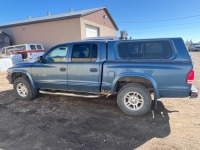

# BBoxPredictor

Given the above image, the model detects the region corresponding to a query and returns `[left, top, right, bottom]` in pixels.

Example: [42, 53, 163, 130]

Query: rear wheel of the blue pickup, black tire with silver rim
[117, 83, 152, 116]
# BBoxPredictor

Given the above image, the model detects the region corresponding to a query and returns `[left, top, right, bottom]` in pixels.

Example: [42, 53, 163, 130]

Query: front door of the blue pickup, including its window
[31, 45, 68, 90]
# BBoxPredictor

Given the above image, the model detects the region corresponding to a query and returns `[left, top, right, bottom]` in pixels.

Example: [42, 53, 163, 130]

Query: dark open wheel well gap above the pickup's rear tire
[116, 77, 154, 93]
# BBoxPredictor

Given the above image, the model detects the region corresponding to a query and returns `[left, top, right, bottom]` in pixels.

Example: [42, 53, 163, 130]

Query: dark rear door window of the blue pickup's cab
[71, 44, 97, 62]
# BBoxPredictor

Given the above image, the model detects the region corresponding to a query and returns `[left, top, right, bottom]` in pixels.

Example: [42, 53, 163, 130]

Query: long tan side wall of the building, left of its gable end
[2, 18, 81, 50]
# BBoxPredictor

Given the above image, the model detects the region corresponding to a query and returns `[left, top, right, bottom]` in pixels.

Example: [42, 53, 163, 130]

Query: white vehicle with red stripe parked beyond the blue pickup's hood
[1, 44, 45, 62]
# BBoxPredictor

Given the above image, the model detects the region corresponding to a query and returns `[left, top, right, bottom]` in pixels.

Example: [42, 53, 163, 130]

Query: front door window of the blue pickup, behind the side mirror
[45, 46, 68, 63]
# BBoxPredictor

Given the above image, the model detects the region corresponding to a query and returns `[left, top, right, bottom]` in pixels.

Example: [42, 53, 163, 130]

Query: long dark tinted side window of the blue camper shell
[118, 41, 172, 59]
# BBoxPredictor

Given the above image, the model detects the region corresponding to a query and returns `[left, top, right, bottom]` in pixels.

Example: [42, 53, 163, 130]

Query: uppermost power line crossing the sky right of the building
[117, 15, 200, 23]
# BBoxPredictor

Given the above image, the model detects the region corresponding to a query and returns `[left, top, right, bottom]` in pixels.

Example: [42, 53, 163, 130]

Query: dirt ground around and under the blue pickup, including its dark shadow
[0, 52, 200, 150]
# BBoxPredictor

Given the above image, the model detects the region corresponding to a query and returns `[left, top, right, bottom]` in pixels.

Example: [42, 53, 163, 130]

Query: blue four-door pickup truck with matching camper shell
[7, 38, 198, 116]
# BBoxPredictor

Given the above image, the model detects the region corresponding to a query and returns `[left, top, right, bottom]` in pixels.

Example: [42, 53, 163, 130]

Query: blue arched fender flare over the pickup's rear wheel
[111, 73, 160, 99]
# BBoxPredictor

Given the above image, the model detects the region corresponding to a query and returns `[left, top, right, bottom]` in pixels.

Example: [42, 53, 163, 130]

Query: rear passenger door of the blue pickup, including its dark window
[67, 43, 102, 92]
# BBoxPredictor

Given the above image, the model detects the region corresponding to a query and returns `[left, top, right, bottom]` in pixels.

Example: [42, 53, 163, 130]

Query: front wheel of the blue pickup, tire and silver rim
[13, 77, 38, 100]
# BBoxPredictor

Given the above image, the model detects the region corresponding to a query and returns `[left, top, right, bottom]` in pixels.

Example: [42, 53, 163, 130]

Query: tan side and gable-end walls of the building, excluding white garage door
[1, 10, 117, 50]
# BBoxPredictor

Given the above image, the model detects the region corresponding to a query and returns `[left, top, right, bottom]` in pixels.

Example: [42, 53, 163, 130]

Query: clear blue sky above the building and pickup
[0, 0, 200, 42]
